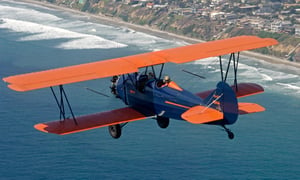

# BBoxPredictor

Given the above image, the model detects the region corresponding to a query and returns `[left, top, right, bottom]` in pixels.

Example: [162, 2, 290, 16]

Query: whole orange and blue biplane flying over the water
[3, 36, 278, 139]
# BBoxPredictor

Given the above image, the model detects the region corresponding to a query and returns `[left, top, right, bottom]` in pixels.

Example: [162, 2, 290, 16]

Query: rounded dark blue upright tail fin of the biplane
[204, 81, 239, 125]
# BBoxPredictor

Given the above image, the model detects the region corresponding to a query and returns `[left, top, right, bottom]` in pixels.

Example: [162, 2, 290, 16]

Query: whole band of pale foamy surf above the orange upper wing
[0, 1, 182, 51]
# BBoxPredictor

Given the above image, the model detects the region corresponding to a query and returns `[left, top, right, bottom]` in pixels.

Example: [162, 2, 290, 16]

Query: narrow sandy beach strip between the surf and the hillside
[14, 0, 300, 72]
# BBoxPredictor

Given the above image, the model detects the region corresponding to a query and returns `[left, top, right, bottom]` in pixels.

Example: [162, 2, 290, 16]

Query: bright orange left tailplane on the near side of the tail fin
[181, 106, 223, 124]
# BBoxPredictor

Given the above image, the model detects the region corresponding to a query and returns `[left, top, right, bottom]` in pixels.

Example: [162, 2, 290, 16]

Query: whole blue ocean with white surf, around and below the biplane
[0, 0, 300, 180]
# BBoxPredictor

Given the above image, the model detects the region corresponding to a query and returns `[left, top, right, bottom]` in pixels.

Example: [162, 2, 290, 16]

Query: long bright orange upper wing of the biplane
[3, 36, 278, 91]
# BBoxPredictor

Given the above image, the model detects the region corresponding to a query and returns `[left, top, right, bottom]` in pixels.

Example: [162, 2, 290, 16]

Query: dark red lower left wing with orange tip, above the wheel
[34, 107, 147, 135]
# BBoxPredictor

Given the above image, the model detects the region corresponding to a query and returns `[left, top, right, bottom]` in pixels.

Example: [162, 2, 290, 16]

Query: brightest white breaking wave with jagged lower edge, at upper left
[0, 19, 127, 49]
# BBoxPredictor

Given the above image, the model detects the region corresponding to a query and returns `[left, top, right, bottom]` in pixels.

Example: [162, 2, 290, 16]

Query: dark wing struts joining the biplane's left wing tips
[50, 85, 78, 125]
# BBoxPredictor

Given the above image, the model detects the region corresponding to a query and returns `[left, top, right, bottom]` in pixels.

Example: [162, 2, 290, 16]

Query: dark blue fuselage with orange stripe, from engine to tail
[117, 73, 203, 120]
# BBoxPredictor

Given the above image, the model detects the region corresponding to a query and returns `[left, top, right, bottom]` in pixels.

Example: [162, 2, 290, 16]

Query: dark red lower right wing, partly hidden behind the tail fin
[196, 83, 264, 99]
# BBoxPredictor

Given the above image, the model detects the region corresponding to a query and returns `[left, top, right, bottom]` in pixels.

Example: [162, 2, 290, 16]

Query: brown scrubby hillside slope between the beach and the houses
[39, 0, 300, 61]
